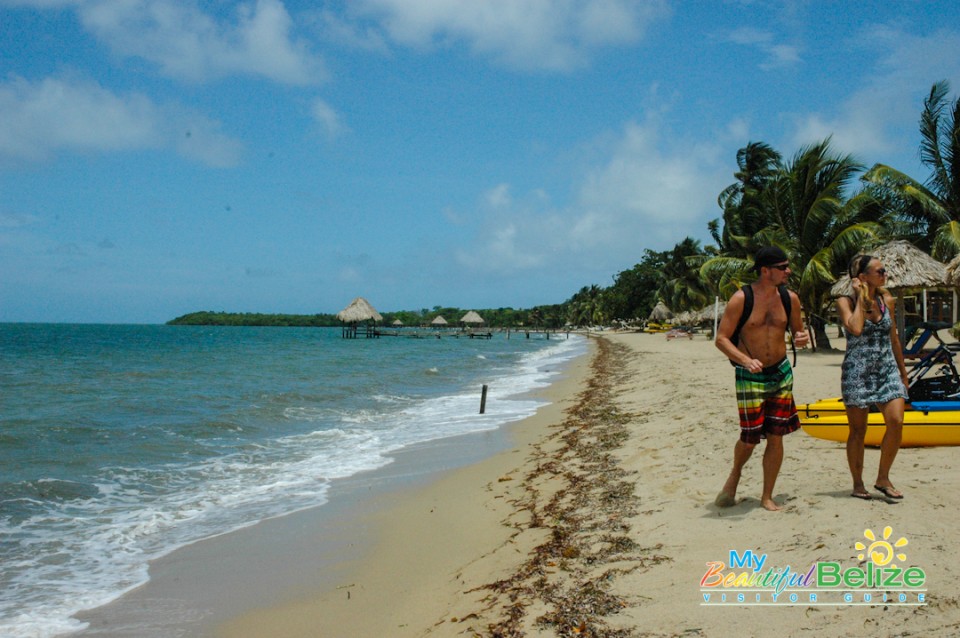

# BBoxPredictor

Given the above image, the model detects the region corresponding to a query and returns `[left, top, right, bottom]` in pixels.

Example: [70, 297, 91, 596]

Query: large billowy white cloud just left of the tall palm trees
[456, 121, 732, 275]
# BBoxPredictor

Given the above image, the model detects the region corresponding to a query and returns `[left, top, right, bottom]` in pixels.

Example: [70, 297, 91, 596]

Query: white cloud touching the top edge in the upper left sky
[78, 0, 325, 85]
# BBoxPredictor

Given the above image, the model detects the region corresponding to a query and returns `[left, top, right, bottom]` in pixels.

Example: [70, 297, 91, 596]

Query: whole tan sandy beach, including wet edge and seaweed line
[84, 333, 960, 638]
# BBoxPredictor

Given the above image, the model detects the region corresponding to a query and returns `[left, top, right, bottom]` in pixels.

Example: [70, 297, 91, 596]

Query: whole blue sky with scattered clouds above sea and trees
[0, 0, 960, 323]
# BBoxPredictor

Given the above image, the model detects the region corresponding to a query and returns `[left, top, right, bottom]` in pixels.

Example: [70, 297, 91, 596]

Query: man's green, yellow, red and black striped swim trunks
[736, 358, 800, 445]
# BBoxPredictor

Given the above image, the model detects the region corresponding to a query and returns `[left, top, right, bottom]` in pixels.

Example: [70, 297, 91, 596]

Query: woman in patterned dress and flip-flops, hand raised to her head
[837, 255, 908, 500]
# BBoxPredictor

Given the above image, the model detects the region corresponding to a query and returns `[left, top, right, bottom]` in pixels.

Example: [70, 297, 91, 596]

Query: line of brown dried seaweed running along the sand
[462, 339, 669, 638]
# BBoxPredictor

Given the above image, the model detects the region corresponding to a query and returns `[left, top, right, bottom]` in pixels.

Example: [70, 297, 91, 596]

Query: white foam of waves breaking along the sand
[0, 328, 585, 638]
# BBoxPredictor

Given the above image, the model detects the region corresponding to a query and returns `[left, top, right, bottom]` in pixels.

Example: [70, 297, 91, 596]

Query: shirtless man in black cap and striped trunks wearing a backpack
[715, 246, 809, 511]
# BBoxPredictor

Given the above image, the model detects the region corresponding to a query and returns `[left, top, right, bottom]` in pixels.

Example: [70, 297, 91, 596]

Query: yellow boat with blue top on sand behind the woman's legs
[797, 398, 960, 447]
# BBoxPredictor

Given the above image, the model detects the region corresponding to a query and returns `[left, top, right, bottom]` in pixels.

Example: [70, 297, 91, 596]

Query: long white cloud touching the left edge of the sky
[0, 78, 240, 166]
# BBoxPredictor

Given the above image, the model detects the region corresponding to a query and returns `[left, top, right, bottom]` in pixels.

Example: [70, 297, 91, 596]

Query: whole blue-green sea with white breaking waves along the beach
[0, 324, 587, 638]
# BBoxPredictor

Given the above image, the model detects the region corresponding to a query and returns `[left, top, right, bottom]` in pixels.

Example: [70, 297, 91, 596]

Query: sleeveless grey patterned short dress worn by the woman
[840, 299, 907, 408]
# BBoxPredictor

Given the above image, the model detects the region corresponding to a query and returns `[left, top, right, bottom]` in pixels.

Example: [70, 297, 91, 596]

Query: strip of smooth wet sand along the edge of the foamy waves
[71, 338, 592, 638]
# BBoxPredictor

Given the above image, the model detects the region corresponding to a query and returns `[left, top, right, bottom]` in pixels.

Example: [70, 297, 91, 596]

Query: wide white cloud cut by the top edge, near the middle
[352, 0, 669, 71]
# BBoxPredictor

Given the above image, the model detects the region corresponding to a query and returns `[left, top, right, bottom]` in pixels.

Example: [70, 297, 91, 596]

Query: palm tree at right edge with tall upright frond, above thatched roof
[863, 80, 960, 261]
